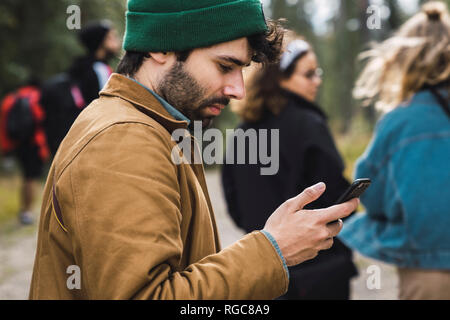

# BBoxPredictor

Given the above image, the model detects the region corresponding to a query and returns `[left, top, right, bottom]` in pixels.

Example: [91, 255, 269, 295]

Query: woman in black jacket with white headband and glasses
[222, 39, 357, 299]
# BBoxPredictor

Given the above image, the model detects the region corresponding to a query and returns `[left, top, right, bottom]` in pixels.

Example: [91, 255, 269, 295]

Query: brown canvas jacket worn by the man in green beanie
[29, 74, 288, 299]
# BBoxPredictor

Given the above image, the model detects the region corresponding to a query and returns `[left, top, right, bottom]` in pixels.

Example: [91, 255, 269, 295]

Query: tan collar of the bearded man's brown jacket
[100, 73, 188, 133]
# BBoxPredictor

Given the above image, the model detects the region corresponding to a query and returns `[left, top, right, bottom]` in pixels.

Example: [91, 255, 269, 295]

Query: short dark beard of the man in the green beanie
[156, 61, 230, 128]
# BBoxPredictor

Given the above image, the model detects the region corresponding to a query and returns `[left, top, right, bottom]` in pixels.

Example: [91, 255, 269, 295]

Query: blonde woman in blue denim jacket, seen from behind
[340, 2, 450, 299]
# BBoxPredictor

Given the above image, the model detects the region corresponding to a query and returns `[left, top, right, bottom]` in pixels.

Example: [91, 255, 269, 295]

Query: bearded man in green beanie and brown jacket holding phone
[30, 0, 358, 299]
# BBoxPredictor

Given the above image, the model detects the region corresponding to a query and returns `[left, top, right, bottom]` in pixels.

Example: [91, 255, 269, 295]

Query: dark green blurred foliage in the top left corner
[0, 0, 126, 96]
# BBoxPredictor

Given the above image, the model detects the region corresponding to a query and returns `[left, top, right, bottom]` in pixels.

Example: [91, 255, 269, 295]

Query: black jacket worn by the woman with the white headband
[222, 91, 356, 299]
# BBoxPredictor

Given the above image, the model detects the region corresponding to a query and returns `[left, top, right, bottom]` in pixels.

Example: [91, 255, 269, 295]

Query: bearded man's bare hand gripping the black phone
[263, 182, 359, 266]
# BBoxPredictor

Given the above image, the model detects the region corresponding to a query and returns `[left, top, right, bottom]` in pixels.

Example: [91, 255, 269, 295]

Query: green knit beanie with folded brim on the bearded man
[123, 0, 267, 52]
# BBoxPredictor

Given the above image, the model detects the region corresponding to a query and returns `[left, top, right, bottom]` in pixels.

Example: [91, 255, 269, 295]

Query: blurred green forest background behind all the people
[0, 0, 450, 221]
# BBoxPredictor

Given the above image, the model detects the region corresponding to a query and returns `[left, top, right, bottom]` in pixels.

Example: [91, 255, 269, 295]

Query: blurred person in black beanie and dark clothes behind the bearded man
[41, 20, 120, 156]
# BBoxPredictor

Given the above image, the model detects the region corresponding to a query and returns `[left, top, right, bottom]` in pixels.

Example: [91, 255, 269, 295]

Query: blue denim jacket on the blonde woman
[339, 90, 450, 269]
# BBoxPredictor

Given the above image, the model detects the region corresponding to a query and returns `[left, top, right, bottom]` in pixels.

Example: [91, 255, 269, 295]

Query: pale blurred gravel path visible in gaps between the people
[0, 171, 398, 300]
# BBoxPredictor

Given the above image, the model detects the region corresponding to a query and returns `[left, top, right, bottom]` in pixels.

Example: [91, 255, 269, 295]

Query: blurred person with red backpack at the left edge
[0, 81, 50, 225]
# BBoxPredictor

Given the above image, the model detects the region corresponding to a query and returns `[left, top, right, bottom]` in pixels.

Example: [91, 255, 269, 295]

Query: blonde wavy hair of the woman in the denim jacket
[353, 1, 450, 112]
